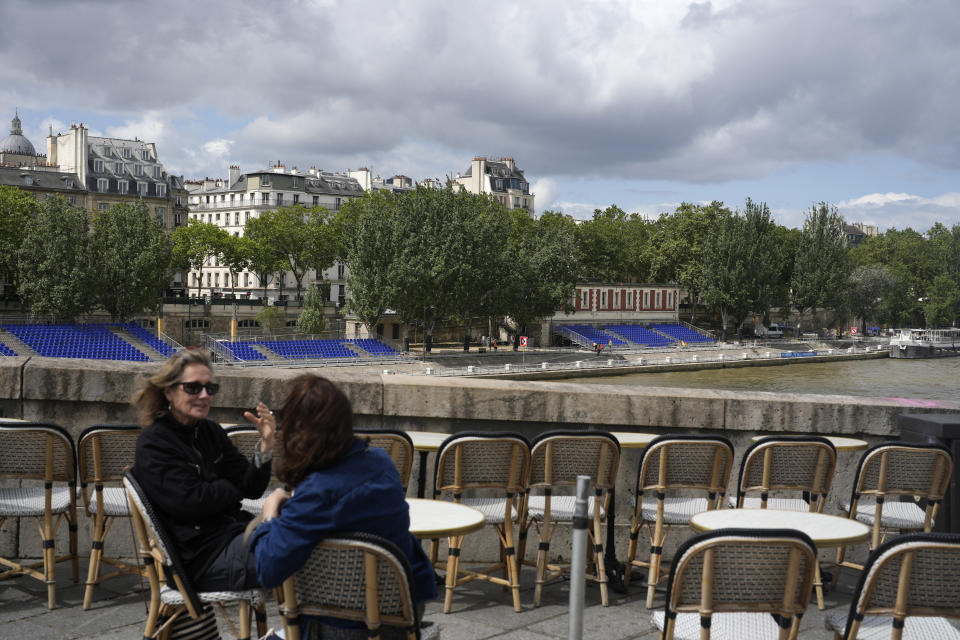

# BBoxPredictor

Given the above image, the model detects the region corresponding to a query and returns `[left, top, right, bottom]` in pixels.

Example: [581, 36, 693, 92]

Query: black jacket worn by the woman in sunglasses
[133, 416, 270, 578]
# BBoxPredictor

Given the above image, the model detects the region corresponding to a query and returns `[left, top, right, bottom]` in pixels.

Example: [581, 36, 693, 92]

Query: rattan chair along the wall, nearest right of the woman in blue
[430, 431, 530, 613]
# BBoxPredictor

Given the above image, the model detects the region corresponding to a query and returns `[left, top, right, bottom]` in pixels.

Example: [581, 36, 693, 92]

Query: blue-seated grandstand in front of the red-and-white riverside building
[554, 323, 716, 351]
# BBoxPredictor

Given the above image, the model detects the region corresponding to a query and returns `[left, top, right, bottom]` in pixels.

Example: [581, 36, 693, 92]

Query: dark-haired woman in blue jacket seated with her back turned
[248, 374, 437, 632]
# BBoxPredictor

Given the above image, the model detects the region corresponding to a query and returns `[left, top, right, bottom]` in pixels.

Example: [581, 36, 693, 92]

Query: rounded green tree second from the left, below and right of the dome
[18, 196, 99, 322]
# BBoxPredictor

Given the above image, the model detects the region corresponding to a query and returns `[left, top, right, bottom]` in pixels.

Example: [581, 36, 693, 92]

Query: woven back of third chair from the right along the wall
[637, 435, 733, 494]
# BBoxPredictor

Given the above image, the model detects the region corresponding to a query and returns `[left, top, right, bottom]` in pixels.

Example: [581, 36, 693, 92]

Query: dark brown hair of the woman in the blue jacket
[276, 373, 353, 486]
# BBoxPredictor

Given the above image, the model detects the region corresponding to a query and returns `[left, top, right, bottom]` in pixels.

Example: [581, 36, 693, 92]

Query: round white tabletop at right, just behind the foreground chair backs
[690, 509, 870, 547]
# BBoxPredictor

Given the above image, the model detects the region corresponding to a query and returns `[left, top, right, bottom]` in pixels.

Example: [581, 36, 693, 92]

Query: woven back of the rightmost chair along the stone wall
[853, 442, 953, 502]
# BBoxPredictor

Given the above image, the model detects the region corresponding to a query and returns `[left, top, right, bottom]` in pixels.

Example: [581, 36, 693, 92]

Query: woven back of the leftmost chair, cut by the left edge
[0, 422, 77, 483]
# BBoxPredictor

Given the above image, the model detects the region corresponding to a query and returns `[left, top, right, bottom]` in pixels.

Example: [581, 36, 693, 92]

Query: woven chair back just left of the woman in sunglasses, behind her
[77, 424, 141, 486]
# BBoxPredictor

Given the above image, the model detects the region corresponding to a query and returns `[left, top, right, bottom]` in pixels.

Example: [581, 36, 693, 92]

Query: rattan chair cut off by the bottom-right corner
[826, 533, 960, 640]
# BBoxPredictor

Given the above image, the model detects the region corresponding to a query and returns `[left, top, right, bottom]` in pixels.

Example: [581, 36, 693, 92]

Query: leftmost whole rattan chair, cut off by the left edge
[0, 422, 80, 609]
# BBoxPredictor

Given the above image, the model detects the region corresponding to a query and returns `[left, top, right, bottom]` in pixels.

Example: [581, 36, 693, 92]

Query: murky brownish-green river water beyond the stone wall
[564, 357, 960, 402]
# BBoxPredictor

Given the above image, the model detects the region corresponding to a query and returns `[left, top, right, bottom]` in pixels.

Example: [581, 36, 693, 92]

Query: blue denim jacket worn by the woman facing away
[248, 439, 437, 601]
